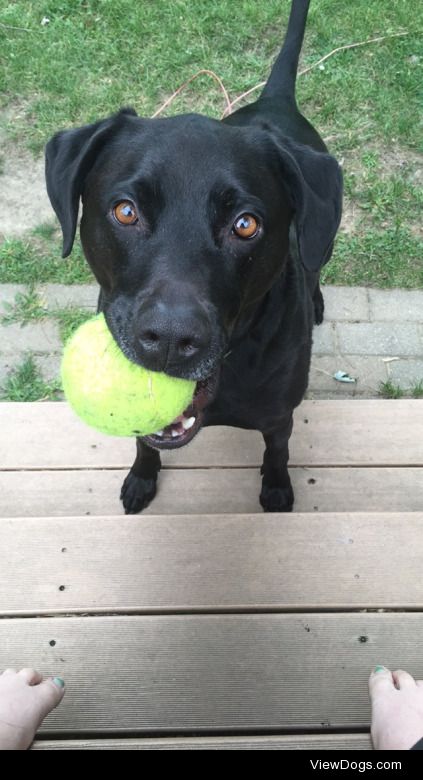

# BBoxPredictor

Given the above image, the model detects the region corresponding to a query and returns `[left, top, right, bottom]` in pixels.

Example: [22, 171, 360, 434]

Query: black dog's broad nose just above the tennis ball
[137, 301, 210, 371]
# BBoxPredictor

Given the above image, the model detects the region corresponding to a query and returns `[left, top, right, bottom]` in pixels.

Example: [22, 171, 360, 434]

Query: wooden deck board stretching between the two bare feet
[0, 612, 423, 737]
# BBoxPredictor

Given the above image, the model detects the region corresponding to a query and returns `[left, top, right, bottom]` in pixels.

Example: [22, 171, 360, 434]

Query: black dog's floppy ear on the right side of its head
[266, 136, 342, 271]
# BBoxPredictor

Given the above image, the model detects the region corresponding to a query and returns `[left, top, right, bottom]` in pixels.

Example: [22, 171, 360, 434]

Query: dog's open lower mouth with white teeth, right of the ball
[141, 372, 218, 450]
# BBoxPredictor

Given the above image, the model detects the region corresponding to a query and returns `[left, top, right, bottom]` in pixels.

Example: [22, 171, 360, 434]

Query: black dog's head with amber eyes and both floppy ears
[46, 109, 341, 446]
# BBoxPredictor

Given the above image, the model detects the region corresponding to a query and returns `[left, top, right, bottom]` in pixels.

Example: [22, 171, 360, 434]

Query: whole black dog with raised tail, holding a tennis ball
[46, 0, 342, 513]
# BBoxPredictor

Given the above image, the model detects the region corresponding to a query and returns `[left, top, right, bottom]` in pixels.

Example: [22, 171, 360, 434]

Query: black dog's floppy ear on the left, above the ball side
[46, 108, 137, 257]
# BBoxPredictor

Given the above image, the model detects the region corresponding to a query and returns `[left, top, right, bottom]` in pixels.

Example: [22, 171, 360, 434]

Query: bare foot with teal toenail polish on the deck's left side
[0, 669, 65, 750]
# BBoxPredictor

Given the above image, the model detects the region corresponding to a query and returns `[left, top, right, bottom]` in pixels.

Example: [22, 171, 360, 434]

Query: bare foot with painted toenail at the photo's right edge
[369, 666, 423, 750]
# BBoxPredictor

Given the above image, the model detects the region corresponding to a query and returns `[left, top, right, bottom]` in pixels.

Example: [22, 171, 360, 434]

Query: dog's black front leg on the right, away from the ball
[260, 412, 294, 512]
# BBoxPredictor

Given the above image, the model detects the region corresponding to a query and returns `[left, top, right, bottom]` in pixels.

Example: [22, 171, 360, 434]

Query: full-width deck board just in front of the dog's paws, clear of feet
[0, 512, 423, 616]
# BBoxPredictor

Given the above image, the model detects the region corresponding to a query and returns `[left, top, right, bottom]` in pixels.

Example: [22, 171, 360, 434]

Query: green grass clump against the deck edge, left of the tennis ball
[0, 355, 61, 401]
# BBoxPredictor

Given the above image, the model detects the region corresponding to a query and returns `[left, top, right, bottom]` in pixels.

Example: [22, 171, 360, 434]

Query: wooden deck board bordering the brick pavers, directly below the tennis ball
[0, 400, 423, 469]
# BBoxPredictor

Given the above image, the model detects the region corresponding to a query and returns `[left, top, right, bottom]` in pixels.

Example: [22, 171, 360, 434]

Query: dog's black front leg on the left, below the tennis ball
[120, 438, 161, 515]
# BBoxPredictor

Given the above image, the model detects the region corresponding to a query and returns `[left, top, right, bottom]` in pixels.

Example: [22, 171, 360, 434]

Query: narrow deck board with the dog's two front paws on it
[0, 467, 423, 517]
